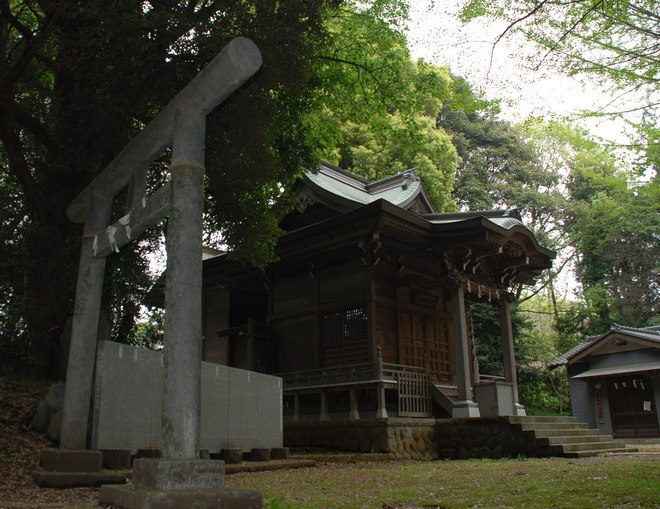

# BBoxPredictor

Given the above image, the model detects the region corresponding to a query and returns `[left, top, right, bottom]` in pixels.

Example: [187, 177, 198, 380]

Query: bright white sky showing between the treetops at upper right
[407, 0, 624, 141]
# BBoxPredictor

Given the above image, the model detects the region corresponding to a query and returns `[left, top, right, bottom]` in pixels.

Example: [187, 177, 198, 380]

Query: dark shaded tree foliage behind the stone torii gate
[0, 0, 346, 374]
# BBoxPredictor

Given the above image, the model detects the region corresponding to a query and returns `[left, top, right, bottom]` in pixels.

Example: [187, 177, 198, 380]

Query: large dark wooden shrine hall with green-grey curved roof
[204, 163, 554, 422]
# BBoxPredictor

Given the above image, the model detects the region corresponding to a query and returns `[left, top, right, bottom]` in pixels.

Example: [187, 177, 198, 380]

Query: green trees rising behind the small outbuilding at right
[568, 159, 660, 332]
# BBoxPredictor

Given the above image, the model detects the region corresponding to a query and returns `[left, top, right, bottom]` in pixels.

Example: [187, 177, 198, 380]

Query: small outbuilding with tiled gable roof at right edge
[550, 325, 660, 438]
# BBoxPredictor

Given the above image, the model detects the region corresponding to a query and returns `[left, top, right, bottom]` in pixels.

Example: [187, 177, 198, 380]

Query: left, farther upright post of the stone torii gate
[60, 194, 112, 450]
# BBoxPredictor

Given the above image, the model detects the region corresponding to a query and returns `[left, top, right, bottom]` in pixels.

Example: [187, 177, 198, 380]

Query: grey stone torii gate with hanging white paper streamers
[42, 37, 261, 507]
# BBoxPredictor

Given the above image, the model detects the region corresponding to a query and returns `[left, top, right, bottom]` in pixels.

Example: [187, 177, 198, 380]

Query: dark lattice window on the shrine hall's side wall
[320, 306, 369, 367]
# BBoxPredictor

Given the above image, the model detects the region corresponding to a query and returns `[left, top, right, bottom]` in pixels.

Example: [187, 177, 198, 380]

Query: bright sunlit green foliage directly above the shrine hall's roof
[311, 3, 458, 210]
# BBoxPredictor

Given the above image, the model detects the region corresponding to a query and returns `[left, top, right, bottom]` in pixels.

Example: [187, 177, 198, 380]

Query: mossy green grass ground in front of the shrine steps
[226, 455, 660, 509]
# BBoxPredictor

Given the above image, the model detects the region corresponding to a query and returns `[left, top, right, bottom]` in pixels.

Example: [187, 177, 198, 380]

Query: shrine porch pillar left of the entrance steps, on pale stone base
[451, 284, 479, 417]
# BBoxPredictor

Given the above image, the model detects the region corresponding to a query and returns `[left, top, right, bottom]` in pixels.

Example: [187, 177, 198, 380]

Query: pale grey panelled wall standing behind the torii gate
[92, 341, 282, 453]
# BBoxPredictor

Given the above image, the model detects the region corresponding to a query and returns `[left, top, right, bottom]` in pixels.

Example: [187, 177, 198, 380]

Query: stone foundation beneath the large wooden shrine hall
[284, 417, 546, 460]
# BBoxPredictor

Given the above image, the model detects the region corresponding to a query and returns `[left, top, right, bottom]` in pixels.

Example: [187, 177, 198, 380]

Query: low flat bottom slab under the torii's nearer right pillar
[99, 486, 263, 509]
